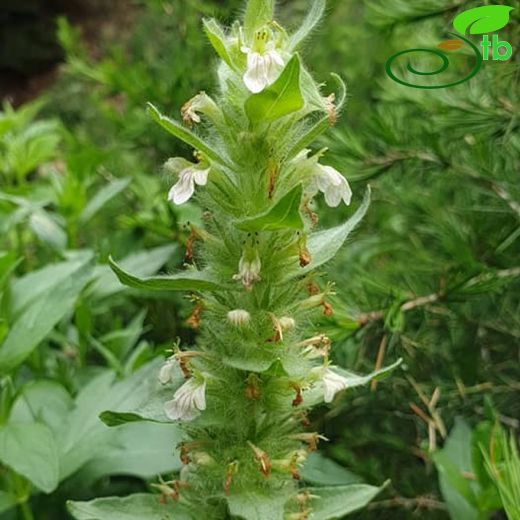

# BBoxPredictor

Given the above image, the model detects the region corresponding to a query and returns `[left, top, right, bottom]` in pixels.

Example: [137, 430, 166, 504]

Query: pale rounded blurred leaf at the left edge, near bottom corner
[0, 422, 59, 493]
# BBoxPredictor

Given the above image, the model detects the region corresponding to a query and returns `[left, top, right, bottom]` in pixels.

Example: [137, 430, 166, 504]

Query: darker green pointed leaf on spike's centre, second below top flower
[235, 184, 303, 231]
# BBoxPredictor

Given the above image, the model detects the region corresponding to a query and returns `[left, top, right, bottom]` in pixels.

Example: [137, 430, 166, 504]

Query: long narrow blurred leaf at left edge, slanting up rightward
[0, 253, 93, 373]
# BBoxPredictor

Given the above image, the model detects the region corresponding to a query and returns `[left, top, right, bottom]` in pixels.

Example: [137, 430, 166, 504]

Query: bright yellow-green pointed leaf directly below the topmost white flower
[245, 54, 304, 124]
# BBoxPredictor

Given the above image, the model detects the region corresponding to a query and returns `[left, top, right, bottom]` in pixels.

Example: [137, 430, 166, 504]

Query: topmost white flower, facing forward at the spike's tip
[242, 31, 284, 94]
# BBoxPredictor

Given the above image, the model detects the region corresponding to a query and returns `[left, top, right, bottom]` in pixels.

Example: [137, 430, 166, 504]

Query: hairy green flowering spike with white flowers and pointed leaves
[70, 0, 398, 520]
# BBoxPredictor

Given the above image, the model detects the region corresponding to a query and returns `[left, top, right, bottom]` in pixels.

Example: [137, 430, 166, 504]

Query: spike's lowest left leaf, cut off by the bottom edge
[67, 493, 193, 520]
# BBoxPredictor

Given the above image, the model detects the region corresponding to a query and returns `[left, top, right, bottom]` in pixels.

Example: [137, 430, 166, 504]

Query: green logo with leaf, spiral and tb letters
[385, 5, 513, 89]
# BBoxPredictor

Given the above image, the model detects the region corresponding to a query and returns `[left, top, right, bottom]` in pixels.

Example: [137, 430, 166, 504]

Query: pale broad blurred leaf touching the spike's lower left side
[80, 420, 182, 482]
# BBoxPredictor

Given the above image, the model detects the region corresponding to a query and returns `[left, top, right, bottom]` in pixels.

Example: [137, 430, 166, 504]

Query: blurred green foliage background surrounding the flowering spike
[0, 0, 520, 520]
